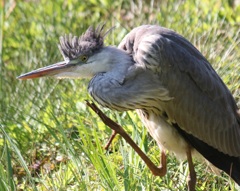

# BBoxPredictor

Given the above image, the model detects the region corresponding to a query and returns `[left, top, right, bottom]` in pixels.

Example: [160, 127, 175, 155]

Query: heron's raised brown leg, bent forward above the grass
[86, 100, 167, 176]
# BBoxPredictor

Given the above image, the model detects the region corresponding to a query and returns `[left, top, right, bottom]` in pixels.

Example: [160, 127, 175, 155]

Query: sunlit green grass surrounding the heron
[0, 0, 240, 191]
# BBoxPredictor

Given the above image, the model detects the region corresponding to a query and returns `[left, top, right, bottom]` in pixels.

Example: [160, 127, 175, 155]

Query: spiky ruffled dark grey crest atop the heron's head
[58, 24, 113, 60]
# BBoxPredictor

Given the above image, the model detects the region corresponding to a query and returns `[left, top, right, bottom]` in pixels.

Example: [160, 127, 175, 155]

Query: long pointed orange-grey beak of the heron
[17, 61, 74, 80]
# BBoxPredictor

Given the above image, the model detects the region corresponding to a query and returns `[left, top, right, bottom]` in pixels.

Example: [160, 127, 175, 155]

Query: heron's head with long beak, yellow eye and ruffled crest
[18, 25, 120, 79]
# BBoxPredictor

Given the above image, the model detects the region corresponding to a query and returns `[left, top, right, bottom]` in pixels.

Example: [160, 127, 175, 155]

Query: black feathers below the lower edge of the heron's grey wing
[174, 124, 240, 185]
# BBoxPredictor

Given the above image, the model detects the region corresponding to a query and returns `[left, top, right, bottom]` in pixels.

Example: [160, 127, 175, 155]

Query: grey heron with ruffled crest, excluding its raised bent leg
[18, 25, 240, 190]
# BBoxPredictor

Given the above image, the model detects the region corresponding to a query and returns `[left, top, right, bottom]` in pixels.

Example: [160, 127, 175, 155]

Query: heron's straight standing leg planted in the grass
[187, 147, 197, 191]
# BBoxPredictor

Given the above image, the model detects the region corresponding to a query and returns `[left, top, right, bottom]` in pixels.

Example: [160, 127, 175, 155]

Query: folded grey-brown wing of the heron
[119, 25, 240, 157]
